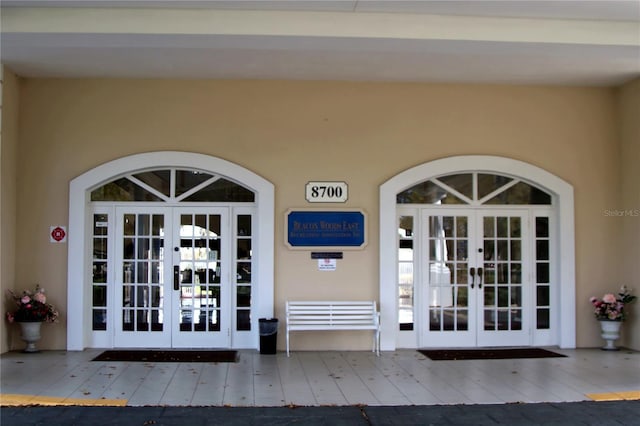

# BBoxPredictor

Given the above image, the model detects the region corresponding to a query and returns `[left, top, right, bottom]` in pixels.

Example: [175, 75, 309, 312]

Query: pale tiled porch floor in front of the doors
[0, 349, 640, 406]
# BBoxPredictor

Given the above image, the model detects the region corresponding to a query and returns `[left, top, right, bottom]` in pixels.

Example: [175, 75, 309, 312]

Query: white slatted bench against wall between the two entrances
[287, 301, 380, 356]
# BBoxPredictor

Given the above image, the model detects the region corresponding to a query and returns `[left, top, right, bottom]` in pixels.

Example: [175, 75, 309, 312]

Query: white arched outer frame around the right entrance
[379, 155, 576, 351]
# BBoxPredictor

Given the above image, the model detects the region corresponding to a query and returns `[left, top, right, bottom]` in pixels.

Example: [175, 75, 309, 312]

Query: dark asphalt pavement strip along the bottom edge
[0, 400, 640, 426]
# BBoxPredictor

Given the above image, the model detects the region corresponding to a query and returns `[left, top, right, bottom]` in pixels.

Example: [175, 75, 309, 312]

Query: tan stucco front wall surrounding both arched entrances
[2, 79, 621, 349]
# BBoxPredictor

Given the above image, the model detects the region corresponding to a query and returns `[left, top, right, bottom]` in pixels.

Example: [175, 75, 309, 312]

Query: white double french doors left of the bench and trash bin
[114, 207, 232, 348]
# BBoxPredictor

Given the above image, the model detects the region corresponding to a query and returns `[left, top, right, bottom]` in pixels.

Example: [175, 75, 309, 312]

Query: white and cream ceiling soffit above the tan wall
[0, 0, 640, 86]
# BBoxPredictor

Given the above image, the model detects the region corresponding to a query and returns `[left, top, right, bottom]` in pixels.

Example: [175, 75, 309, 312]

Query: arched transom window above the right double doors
[396, 172, 552, 205]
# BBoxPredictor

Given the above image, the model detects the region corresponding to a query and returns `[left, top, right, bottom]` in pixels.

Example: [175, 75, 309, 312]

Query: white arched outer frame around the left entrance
[67, 151, 275, 350]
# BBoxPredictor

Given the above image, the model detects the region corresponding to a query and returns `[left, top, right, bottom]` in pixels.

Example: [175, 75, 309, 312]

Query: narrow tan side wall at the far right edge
[614, 79, 640, 350]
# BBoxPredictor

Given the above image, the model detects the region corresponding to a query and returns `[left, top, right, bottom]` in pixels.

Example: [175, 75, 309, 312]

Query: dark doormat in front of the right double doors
[418, 348, 566, 361]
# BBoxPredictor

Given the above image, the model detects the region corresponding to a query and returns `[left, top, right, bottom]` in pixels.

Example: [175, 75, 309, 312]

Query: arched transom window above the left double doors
[91, 168, 255, 203]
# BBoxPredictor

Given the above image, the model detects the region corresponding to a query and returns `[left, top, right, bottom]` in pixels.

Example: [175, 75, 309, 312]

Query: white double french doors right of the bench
[419, 209, 533, 347]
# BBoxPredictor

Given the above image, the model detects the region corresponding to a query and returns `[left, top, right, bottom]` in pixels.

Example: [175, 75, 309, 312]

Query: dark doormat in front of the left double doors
[92, 350, 238, 362]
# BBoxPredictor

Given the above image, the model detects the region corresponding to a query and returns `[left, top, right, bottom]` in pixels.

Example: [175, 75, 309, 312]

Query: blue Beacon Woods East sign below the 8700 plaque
[287, 211, 365, 247]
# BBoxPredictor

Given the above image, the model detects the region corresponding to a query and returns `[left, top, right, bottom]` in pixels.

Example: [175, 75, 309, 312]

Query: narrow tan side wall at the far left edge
[0, 68, 20, 353]
